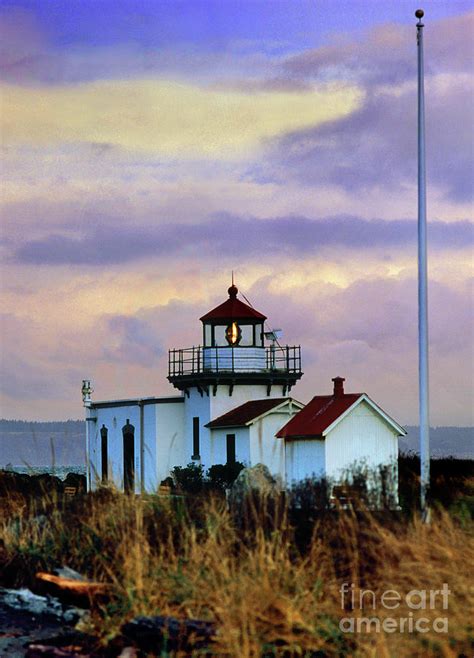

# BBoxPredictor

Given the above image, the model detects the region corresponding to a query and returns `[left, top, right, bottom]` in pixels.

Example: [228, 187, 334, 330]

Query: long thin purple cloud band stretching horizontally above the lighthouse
[14, 214, 474, 266]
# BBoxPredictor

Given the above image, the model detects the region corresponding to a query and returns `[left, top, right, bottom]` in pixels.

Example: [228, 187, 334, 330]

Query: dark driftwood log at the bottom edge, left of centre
[121, 616, 216, 655]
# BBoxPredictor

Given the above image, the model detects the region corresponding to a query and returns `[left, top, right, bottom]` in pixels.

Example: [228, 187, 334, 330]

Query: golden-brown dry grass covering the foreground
[0, 484, 474, 658]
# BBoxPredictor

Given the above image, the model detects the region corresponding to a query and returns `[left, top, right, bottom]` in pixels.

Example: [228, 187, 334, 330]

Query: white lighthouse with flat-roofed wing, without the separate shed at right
[83, 284, 303, 493]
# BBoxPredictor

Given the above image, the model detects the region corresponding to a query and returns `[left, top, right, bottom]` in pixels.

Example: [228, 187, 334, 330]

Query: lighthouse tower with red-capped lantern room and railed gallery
[168, 284, 303, 467]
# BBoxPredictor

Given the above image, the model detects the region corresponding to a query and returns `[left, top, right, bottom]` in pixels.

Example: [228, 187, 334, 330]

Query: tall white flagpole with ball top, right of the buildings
[415, 9, 430, 520]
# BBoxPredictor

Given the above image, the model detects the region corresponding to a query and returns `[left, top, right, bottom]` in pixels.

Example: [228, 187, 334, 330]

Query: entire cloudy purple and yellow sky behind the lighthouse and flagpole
[0, 0, 474, 426]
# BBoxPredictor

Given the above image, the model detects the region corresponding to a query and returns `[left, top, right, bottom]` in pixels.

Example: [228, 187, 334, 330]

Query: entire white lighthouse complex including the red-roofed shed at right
[83, 284, 405, 493]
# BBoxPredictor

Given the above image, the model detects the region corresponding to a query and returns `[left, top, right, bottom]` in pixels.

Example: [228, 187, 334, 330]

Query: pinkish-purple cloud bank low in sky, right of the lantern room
[246, 276, 474, 425]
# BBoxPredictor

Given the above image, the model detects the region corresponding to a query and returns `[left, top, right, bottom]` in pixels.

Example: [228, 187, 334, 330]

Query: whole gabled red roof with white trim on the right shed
[276, 393, 406, 439]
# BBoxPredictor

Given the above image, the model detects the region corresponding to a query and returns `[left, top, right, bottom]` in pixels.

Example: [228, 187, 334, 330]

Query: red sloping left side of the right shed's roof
[276, 393, 363, 439]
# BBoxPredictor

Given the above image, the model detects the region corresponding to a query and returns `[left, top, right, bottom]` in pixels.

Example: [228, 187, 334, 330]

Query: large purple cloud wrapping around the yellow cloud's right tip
[269, 12, 474, 202]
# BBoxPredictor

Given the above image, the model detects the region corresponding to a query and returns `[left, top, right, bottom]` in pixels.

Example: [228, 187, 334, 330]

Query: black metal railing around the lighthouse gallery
[168, 345, 301, 378]
